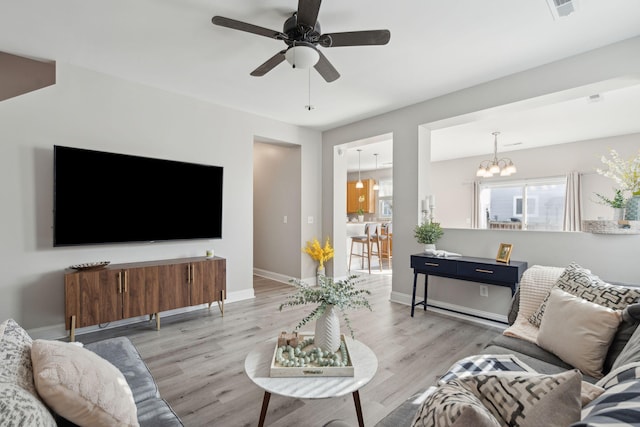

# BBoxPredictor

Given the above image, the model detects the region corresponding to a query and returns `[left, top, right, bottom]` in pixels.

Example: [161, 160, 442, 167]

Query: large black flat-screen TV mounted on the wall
[53, 145, 223, 246]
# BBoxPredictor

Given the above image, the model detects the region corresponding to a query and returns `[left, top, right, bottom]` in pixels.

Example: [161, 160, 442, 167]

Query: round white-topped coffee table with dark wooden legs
[244, 337, 378, 427]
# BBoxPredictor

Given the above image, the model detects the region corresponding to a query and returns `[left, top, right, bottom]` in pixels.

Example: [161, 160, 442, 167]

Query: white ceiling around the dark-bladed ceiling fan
[0, 0, 640, 170]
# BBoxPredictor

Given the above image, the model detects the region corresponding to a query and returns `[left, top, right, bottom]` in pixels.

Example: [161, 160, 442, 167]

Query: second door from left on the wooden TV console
[122, 266, 160, 319]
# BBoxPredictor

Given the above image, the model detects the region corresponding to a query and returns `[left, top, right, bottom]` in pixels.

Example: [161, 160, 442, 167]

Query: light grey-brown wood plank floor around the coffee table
[77, 275, 499, 427]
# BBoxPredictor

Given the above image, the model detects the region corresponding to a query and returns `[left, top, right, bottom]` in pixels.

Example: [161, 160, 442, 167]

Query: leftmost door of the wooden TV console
[65, 269, 122, 328]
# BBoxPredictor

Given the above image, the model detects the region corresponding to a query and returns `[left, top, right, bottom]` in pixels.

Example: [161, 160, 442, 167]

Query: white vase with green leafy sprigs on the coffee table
[280, 275, 371, 351]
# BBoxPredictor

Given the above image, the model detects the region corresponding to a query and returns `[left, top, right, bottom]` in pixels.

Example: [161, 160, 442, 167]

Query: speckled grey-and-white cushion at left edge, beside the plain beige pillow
[0, 319, 56, 426]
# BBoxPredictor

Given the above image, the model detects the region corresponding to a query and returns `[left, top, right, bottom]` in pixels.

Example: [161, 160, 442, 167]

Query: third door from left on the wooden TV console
[156, 262, 191, 312]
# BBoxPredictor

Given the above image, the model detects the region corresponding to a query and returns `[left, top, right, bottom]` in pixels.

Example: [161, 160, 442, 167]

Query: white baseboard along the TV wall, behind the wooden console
[27, 288, 255, 341]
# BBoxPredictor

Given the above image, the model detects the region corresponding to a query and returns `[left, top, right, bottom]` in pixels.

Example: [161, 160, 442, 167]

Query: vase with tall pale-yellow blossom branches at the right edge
[596, 149, 640, 221]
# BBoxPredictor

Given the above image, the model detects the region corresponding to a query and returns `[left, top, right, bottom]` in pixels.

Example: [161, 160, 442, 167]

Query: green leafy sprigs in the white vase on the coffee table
[279, 274, 371, 337]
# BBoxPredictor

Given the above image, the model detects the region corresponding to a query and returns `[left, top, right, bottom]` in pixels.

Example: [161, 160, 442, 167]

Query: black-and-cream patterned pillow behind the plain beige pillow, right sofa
[528, 263, 640, 327]
